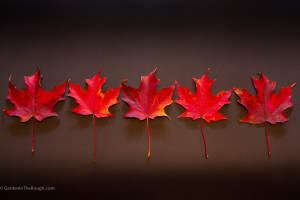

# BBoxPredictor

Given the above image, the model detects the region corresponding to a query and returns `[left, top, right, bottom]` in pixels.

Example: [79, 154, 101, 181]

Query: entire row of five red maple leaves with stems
[4, 69, 295, 161]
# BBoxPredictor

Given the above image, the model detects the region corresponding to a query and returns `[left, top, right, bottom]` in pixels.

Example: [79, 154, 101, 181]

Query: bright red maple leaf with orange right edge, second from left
[68, 69, 121, 161]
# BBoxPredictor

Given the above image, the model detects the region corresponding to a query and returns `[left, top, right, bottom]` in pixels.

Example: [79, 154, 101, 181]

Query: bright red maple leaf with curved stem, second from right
[175, 72, 233, 158]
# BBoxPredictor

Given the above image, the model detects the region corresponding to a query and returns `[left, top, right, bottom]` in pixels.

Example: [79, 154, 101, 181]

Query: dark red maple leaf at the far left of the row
[4, 70, 67, 152]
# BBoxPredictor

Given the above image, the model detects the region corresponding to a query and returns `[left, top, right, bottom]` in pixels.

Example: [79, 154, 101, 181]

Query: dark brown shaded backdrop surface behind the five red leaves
[0, 0, 300, 199]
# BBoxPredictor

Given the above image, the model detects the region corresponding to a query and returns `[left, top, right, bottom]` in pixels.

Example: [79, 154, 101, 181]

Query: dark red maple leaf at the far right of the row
[234, 73, 295, 155]
